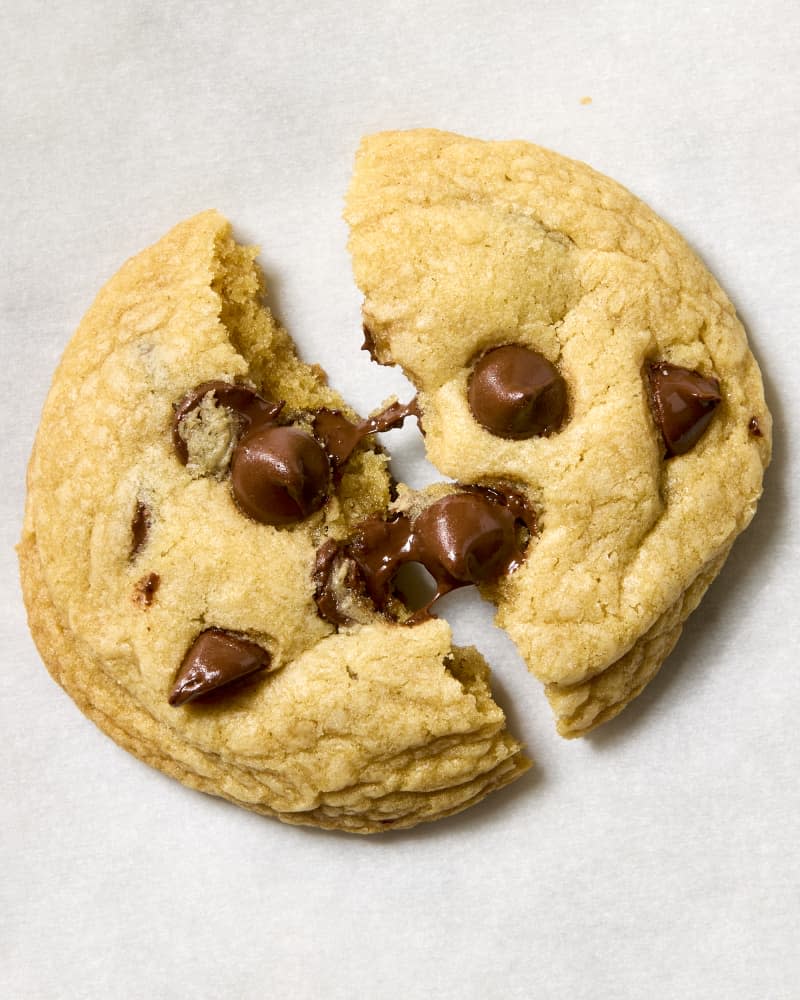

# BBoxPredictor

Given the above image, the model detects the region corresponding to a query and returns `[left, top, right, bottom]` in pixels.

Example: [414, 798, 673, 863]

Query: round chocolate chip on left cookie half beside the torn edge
[231, 425, 330, 525]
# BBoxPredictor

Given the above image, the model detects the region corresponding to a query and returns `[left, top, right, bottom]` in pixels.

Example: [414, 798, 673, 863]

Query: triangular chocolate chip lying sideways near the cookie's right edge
[647, 361, 722, 458]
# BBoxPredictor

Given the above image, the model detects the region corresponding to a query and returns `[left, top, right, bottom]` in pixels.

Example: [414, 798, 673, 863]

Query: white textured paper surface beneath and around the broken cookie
[0, 0, 800, 1000]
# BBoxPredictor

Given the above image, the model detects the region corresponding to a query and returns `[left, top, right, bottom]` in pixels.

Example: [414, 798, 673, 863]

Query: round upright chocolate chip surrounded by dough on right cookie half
[467, 344, 567, 440]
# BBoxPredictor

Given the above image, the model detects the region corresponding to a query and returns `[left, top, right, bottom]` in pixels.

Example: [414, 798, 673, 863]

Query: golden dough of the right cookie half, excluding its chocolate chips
[346, 130, 771, 736]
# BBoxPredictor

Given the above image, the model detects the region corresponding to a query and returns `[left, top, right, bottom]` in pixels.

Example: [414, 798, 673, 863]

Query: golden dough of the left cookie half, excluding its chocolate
[19, 212, 529, 832]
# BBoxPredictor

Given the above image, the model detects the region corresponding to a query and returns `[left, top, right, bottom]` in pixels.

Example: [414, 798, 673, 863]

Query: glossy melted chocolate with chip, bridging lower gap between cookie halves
[314, 486, 536, 625]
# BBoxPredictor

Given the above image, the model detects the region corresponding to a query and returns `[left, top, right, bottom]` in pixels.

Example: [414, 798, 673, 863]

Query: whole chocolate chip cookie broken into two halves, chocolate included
[19, 131, 771, 832]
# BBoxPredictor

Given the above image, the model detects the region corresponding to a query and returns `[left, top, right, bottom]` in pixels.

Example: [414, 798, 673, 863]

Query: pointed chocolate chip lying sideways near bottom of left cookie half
[169, 628, 271, 706]
